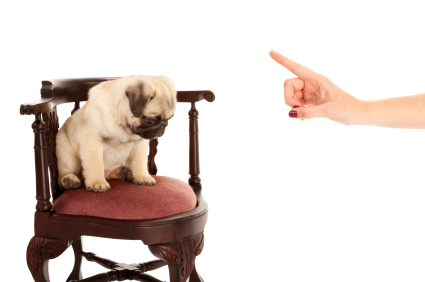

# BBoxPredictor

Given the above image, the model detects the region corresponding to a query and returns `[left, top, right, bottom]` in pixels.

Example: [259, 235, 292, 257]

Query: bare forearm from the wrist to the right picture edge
[358, 93, 425, 129]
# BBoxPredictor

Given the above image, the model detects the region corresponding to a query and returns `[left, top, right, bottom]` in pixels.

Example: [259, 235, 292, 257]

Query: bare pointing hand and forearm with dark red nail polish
[270, 51, 425, 129]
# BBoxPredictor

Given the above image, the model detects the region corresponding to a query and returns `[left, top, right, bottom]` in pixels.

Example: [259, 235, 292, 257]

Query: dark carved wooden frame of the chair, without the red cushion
[20, 78, 215, 282]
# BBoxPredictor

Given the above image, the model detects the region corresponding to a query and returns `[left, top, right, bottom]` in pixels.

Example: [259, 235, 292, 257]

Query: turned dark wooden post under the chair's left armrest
[32, 114, 52, 212]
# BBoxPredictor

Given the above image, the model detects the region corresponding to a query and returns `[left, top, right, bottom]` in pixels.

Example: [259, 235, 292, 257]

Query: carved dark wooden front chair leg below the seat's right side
[149, 233, 204, 282]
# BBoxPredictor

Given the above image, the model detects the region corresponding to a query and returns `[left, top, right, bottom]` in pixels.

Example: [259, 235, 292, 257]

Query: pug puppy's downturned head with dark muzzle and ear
[121, 76, 177, 139]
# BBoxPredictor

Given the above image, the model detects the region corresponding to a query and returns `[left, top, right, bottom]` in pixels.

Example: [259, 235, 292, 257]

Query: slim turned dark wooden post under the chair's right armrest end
[189, 102, 202, 189]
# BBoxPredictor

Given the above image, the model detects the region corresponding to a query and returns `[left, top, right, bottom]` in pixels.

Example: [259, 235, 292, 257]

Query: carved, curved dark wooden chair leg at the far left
[27, 236, 72, 282]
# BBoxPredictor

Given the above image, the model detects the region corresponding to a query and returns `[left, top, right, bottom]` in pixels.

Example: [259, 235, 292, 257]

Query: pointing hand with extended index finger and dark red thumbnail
[270, 51, 366, 125]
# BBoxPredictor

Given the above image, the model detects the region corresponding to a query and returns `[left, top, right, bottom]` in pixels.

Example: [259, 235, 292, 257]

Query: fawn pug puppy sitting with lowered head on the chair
[56, 75, 177, 192]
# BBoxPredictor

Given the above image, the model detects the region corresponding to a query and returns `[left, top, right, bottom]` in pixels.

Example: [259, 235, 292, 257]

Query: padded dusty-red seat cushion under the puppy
[53, 176, 196, 219]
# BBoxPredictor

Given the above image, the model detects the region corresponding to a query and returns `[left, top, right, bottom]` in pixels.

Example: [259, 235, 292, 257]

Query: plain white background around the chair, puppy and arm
[0, 0, 425, 282]
